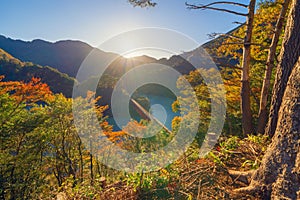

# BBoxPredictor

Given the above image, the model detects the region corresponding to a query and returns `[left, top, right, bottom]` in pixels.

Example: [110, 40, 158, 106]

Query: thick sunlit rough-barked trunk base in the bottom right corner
[242, 57, 300, 199]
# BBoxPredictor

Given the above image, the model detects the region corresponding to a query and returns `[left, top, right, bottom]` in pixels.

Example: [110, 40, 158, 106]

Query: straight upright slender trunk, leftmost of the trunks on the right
[241, 0, 256, 135]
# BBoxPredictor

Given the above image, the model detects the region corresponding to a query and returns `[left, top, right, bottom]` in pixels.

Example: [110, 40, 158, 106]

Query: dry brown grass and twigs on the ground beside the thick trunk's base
[55, 137, 267, 200]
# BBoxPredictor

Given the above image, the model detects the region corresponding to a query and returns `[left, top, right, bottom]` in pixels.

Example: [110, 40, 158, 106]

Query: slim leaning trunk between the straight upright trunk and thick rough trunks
[256, 0, 290, 134]
